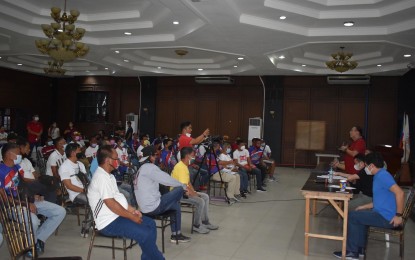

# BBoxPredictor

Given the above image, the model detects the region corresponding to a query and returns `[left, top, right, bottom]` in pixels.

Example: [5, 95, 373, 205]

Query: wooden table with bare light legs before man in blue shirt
[301, 173, 353, 259]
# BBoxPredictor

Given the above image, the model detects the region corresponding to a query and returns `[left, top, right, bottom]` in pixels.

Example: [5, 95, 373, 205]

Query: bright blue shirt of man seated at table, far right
[373, 168, 396, 221]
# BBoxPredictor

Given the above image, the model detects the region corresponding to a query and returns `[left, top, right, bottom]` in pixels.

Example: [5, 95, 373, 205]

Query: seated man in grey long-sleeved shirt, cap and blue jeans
[134, 146, 190, 243]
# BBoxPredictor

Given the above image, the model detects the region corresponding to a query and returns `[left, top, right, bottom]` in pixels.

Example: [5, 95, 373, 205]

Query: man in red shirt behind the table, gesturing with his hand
[334, 126, 366, 174]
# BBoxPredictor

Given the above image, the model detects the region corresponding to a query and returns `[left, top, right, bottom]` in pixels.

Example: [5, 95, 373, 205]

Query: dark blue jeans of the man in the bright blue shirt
[346, 210, 393, 253]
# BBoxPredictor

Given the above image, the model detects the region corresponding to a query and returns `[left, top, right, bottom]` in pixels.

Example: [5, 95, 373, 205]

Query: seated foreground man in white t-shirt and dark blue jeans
[88, 145, 164, 260]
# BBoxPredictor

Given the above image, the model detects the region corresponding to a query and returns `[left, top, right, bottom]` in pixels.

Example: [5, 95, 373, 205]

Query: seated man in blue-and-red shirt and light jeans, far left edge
[0, 143, 66, 257]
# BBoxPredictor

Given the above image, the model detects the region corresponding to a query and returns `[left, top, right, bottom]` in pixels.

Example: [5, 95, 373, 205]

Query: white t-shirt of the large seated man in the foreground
[88, 167, 128, 230]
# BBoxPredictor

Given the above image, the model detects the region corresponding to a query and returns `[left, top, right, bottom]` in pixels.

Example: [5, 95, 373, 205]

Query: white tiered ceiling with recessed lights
[0, 0, 415, 76]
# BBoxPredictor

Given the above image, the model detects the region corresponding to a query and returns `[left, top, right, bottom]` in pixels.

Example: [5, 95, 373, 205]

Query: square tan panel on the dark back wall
[295, 120, 326, 151]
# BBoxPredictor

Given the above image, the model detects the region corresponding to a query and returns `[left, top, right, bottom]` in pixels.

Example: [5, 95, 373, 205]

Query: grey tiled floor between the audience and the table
[0, 168, 415, 260]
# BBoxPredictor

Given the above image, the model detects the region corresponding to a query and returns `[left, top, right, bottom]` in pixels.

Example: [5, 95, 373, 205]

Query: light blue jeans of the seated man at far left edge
[30, 201, 66, 242]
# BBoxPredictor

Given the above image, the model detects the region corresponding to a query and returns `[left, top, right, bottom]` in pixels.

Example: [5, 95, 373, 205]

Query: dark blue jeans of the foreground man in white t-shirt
[100, 216, 164, 260]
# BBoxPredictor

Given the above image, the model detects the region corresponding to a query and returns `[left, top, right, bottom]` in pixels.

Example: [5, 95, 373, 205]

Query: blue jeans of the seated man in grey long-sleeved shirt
[145, 187, 183, 234]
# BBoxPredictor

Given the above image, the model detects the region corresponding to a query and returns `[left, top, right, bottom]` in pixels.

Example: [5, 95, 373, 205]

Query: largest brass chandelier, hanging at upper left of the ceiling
[35, 0, 89, 73]
